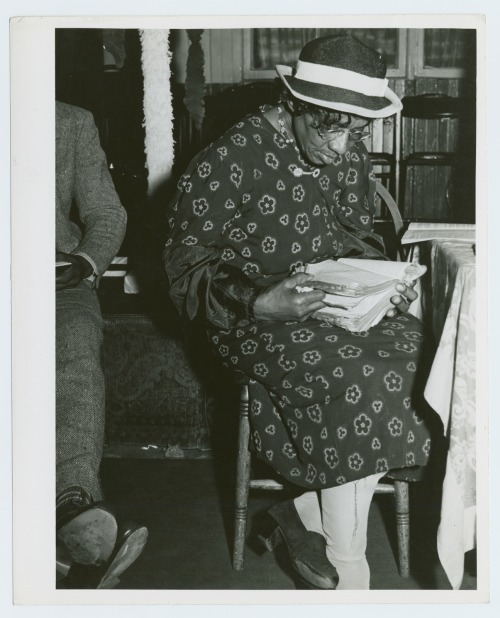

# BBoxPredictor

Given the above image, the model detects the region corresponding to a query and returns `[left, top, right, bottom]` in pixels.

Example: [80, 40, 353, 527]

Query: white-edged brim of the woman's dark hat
[276, 65, 403, 118]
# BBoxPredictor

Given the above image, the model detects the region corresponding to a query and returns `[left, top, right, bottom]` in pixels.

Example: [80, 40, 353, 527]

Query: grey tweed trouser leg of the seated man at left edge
[56, 282, 104, 500]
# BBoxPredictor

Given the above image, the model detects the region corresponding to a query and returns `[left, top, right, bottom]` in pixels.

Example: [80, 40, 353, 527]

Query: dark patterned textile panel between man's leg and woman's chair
[103, 314, 210, 456]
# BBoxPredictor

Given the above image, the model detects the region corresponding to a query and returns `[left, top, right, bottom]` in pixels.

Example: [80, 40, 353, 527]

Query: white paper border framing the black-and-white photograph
[3, 2, 498, 615]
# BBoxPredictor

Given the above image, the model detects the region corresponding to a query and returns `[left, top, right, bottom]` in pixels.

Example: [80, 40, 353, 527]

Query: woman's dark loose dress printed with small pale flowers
[165, 113, 430, 489]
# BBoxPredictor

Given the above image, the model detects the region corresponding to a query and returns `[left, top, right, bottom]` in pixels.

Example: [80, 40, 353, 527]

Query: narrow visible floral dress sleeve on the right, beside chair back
[337, 144, 387, 259]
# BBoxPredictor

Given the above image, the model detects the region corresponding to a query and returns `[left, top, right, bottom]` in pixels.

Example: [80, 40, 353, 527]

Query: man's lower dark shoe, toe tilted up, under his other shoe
[61, 523, 148, 589]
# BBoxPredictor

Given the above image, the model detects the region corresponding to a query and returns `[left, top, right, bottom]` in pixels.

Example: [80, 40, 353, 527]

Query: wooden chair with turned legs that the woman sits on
[233, 181, 419, 577]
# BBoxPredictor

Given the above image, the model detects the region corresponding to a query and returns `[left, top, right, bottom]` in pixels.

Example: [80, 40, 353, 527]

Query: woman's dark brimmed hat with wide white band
[276, 34, 402, 118]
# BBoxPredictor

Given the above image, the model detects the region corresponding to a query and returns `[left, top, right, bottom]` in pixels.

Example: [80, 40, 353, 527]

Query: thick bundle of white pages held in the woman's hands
[298, 258, 427, 333]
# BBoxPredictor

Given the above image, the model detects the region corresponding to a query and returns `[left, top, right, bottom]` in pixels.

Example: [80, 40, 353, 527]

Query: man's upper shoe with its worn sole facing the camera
[56, 502, 118, 566]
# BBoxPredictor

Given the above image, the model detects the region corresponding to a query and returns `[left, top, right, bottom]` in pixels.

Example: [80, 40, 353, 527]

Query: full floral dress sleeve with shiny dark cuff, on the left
[163, 146, 262, 328]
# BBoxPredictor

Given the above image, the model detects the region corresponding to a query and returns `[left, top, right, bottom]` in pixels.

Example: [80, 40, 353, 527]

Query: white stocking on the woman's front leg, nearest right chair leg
[321, 473, 385, 590]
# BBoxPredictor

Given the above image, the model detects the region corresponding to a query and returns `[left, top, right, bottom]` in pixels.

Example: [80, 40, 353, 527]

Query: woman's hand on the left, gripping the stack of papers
[253, 273, 326, 322]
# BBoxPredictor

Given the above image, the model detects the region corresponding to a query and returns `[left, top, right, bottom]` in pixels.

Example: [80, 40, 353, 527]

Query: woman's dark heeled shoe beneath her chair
[261, 500, 339, 590]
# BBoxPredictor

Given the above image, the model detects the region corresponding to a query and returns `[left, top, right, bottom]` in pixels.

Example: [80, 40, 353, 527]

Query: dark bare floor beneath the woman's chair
[95, 458, 477, 590]
